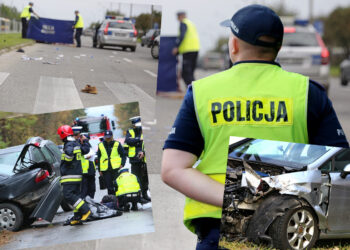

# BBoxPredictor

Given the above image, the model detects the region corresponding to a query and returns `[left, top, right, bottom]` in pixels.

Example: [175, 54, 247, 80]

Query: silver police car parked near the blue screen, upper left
[96, 19, 137, 51]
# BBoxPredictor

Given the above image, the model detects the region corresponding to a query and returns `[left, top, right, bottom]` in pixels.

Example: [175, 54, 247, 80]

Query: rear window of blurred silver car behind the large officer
[282, 32, 319, 47]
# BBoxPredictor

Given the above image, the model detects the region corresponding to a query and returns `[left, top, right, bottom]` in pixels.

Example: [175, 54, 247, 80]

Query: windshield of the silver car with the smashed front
[229, 139, 333, 168]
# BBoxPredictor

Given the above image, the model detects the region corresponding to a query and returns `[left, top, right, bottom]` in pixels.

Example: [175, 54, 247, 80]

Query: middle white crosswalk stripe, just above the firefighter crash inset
[33, 76, 83, 114]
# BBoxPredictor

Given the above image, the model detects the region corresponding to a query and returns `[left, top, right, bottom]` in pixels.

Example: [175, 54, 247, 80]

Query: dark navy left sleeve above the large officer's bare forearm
[163, 86, 204, 157]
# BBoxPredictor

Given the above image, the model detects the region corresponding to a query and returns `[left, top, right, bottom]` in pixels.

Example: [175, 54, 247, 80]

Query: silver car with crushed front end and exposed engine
[220, 139, 350, 249]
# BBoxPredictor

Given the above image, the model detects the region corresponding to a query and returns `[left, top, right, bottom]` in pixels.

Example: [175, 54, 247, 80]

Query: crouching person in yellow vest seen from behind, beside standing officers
[115, 168, 141, 212]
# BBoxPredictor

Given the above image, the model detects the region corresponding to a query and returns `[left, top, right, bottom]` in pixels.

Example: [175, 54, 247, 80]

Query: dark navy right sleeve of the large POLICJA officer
[307, 80, 349, 148]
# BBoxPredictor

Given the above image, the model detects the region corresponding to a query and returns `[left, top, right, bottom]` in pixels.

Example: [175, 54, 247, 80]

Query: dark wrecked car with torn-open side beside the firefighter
[0, 137, 62, 231]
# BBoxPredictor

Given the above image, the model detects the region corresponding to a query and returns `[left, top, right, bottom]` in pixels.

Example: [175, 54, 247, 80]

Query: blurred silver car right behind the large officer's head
[277, 25, 330, 92]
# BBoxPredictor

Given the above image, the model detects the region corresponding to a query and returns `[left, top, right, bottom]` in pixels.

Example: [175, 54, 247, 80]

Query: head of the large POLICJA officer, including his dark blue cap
[221, 4, 284, 62]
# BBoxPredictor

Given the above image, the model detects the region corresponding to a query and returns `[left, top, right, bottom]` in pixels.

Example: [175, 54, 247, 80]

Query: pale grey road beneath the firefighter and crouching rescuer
[2, 162, 154, 250]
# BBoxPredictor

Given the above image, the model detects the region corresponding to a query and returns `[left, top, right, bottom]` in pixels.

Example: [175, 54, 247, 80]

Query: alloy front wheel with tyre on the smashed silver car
[269, 206, 319, 249]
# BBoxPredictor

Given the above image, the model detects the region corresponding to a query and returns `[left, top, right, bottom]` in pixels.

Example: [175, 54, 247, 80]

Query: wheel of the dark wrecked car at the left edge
[0, 203, 23, 231]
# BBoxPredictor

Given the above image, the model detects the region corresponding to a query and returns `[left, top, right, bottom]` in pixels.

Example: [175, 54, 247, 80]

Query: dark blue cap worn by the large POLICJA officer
[220, 4, 284, 47]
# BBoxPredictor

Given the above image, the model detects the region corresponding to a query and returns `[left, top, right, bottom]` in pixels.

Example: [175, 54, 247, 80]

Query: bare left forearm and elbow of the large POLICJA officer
[161, 148, 224, 207]
